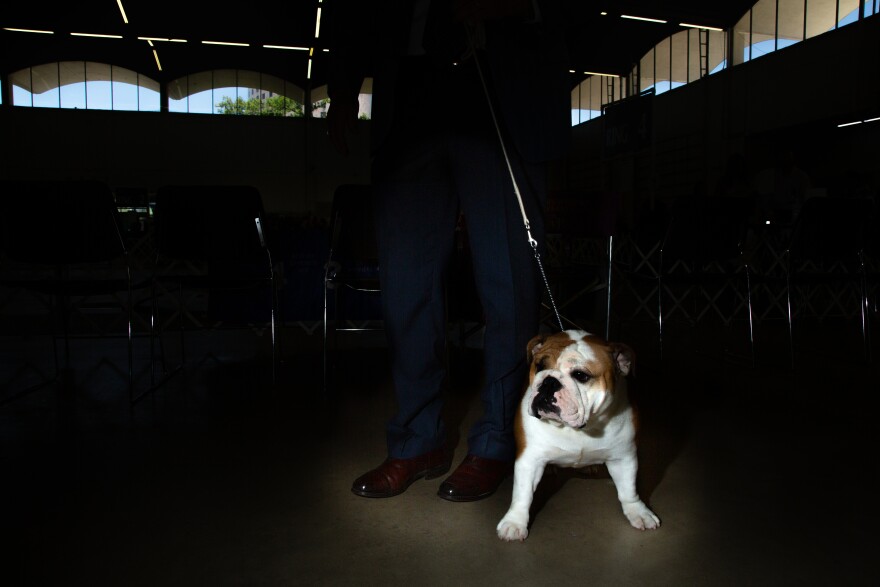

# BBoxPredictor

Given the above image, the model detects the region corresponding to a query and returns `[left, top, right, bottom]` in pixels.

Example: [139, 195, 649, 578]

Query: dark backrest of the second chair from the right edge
[661, 196, 755, 268]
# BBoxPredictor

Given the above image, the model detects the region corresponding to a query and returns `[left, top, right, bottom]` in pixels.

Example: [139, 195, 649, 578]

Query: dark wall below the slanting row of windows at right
[557, 17, 880, 230]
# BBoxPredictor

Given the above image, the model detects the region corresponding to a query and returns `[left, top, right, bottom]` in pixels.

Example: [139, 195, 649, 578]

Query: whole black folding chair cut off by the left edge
[0, 180, 139, 403]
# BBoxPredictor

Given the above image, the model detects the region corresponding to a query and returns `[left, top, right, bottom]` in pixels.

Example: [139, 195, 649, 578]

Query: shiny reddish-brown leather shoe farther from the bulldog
[351, 447, 450, 497]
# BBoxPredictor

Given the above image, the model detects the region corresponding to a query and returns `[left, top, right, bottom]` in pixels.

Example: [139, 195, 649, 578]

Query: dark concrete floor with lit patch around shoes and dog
[0, 326, 880, 587]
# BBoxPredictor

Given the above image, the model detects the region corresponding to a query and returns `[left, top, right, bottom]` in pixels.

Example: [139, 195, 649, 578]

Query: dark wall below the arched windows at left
[0, 107, 369, 216]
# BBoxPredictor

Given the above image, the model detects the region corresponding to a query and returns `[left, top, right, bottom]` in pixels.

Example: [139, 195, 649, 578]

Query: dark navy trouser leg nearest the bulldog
[454, 137, 544, 462]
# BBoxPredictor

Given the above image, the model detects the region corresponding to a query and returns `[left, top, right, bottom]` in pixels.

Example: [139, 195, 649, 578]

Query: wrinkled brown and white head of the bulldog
[526, 330, 635, 428]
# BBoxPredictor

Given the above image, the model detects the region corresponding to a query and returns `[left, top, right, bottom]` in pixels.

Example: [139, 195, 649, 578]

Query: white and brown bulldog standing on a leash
[497, 330, 660, 541]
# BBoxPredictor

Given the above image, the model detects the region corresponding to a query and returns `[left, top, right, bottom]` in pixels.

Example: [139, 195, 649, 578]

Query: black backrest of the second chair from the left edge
[153, 185, 266, 269]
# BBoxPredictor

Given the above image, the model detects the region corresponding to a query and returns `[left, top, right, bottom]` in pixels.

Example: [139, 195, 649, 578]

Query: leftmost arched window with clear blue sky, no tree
[9, 61, 160, 112]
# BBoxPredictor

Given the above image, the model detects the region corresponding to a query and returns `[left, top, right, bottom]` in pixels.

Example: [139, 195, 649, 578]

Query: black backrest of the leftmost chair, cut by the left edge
[0, 180, 126, 265]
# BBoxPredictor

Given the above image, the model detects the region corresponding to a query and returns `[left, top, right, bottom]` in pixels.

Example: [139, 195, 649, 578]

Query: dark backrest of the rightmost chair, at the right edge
[789, 197, 874, 261]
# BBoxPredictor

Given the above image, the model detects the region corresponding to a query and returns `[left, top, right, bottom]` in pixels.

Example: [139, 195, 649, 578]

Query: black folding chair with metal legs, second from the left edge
[150, 185, 278, 388]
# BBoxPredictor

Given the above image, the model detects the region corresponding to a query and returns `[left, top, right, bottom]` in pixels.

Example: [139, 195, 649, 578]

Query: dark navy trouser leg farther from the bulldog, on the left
[374, 140, 458, 458]
